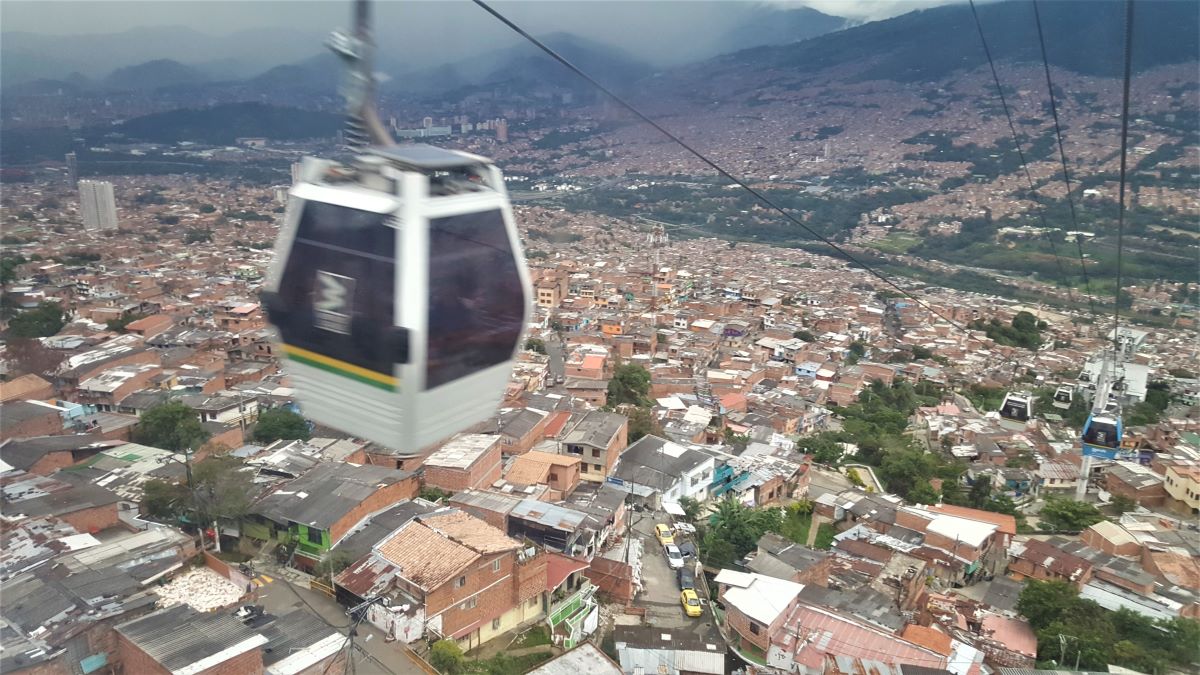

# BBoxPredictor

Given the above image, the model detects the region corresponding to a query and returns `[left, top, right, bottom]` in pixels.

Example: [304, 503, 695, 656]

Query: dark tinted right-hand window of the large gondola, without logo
[425, 210, 524, 389]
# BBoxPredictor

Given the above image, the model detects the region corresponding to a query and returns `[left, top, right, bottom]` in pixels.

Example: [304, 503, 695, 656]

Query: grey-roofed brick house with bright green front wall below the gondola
[241, 462, 420, 568]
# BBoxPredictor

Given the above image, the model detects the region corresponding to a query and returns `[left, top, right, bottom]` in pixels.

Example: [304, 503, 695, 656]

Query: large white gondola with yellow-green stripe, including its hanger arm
[263, 0, 530, 452]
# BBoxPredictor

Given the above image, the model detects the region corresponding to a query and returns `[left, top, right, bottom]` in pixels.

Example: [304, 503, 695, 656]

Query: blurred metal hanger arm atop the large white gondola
[326, 0, 394, 148]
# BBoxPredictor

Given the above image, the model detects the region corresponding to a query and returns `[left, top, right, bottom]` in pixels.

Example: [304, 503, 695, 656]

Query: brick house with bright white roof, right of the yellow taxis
[715, 569, 804, 652]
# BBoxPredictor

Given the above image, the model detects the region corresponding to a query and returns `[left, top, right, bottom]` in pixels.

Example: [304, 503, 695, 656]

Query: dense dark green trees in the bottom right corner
[1016, 580, 1200, 673]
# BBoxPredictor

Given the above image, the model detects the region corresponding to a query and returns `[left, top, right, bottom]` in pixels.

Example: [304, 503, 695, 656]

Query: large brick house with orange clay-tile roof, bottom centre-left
[334, 509, 547, 650]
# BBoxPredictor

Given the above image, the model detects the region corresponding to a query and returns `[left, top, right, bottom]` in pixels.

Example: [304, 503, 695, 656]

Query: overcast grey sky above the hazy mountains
[0, 0, 964, 65]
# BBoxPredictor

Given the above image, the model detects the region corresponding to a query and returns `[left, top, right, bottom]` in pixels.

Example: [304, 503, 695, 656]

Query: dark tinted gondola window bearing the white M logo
[271, 202, 404, 375]
